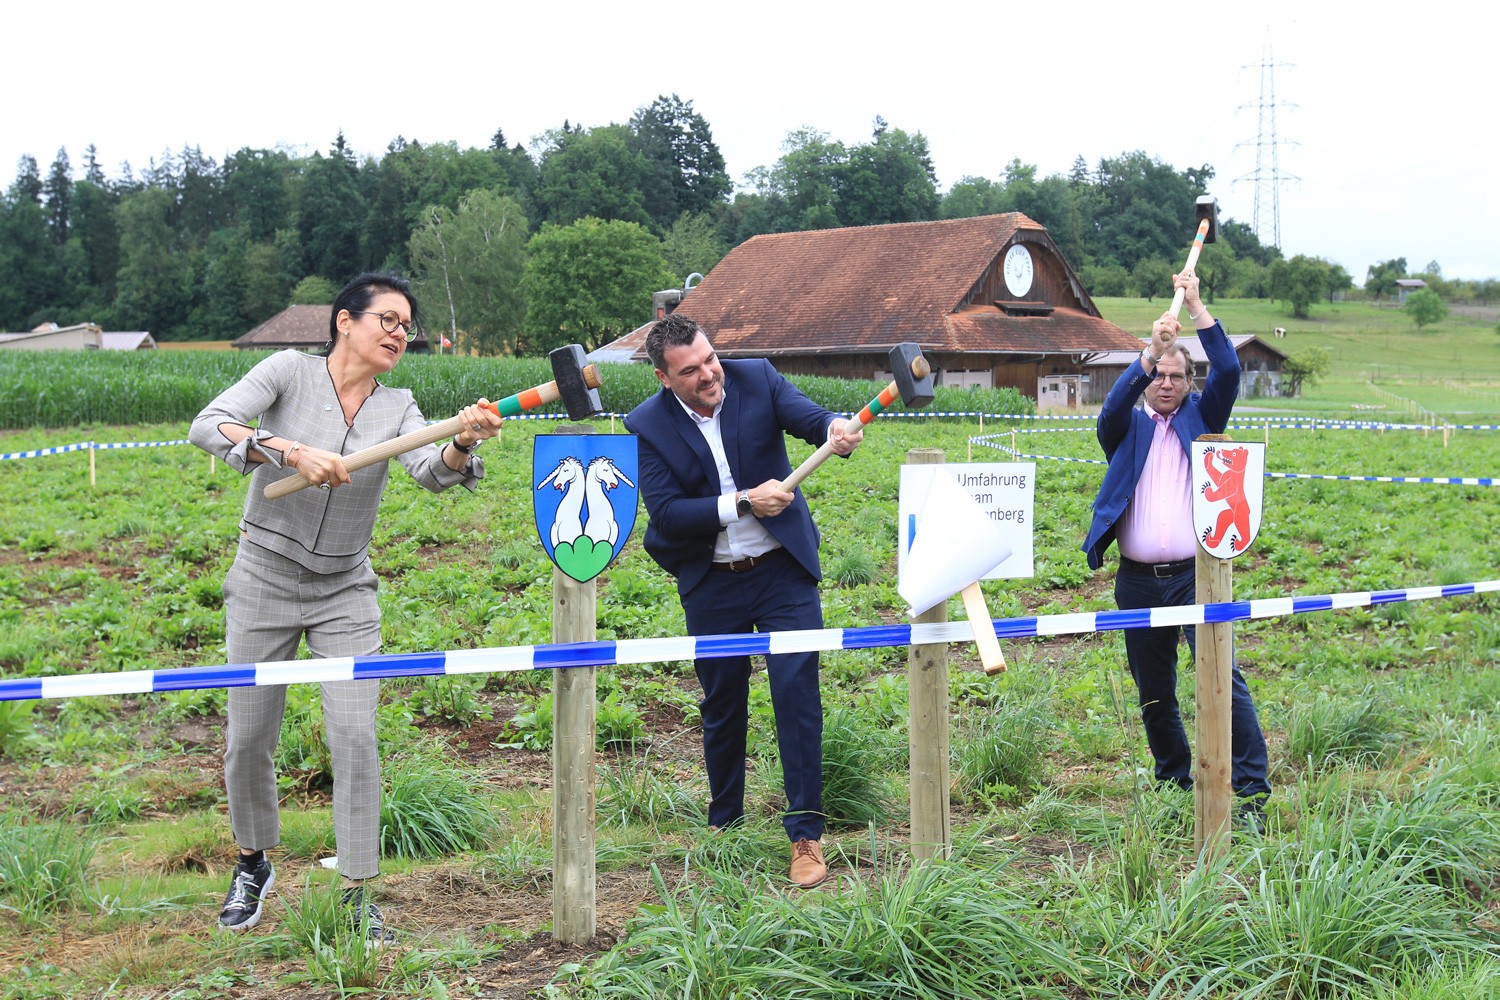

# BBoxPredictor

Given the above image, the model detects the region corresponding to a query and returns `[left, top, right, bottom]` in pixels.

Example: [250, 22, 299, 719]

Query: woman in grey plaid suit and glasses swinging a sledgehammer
[189, 274, 500, 943]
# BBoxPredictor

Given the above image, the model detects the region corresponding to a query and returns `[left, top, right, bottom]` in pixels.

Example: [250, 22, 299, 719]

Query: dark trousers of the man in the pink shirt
[1115, 567, 1271, 798]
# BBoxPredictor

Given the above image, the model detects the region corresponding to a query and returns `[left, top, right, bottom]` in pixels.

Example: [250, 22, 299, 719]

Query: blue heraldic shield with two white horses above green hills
[531, 435, 641, 583]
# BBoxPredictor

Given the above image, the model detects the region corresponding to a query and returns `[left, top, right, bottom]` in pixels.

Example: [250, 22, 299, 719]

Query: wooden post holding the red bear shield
[1193, 435, 1235, 865]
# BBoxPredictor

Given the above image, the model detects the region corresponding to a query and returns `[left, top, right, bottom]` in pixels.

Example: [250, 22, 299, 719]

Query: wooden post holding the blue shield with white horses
[552, 424, 599, 945]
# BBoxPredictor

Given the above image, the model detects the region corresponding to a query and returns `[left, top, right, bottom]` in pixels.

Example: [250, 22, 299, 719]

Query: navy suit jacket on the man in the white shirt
[626, 358, 834, 595]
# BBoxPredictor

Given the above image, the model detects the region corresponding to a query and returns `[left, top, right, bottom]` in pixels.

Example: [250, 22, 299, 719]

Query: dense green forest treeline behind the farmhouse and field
[0, 94, 1494, 354]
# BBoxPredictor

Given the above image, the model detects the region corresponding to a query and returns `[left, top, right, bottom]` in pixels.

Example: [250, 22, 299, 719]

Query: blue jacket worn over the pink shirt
[1083, 322, 1239, 570]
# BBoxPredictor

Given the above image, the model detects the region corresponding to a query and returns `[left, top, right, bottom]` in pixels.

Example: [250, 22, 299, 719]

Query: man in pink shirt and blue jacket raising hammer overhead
[1083, 271, 1271, 829]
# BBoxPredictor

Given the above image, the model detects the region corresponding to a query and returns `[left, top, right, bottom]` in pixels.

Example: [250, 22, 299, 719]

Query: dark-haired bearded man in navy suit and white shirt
[626, 313, 864, 889]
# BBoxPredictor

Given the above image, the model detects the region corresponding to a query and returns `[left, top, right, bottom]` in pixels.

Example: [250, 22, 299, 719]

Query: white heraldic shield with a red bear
[1193, 441, 1266, 559]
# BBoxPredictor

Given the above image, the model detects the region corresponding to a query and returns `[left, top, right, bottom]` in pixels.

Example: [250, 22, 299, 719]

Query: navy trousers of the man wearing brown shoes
[683, 549, 824, 841]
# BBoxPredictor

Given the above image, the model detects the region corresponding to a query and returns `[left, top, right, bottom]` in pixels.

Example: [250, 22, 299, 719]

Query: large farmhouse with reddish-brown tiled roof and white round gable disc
[606, 213, 1140, 405]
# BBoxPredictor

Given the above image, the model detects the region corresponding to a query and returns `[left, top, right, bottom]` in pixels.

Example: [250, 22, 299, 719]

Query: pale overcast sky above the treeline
[0, 0, 1500, 282]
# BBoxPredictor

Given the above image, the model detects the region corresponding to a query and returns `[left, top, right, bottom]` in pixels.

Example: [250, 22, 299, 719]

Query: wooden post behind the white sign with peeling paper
[906, 448, 953, 861]
